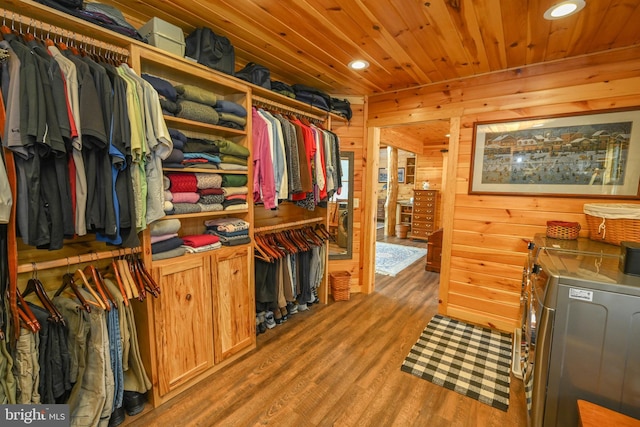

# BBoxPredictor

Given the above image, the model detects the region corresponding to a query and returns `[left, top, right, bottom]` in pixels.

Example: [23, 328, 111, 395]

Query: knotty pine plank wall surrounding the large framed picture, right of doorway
[365, 47, 640, 331]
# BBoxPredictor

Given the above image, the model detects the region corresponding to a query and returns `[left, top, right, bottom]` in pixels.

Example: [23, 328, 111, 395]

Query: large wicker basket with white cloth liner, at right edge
[583, 203, 640, 245]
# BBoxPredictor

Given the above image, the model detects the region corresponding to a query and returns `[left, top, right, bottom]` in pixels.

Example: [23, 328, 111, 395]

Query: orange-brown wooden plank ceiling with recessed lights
[79, 0, 640, 148]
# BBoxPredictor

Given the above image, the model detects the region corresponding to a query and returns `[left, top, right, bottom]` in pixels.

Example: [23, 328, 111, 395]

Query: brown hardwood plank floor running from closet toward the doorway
[127, 232, 526, 427]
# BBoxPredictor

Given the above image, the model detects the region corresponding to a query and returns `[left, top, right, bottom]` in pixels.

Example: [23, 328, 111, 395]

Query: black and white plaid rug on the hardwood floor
[401, 314, 511, 411]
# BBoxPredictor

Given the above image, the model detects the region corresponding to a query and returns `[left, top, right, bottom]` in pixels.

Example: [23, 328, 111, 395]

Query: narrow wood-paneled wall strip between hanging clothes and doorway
[329, 97, 364, 293]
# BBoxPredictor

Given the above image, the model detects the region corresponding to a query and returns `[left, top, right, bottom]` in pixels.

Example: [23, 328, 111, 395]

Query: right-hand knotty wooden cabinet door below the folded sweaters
[211, 246, 256, 363]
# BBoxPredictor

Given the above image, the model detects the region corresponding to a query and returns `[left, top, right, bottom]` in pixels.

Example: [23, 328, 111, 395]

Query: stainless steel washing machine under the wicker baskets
[521, 235, 640, 427]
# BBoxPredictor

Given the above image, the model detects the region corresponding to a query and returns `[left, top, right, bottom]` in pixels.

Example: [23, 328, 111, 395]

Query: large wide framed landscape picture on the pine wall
[469, 109, 640, 198]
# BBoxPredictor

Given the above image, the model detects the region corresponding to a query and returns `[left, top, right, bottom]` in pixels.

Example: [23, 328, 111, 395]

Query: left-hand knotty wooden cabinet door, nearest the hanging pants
[153, 255, 214, 396]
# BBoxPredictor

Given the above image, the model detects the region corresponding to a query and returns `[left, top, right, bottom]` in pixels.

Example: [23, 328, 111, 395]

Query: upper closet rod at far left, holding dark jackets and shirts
[0, 8, 129, 58]
